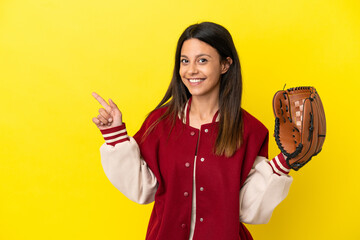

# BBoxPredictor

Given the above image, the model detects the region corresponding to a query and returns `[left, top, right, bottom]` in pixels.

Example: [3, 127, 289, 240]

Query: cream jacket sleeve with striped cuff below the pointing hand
[100, 124, 158, 204]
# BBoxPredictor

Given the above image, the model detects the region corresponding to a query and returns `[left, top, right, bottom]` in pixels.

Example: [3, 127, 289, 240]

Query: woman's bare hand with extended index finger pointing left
[92, 92, 122, 130]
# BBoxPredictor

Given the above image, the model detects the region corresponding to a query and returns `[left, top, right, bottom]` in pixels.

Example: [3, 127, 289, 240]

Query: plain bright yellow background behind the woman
[0, 0, 360, 240]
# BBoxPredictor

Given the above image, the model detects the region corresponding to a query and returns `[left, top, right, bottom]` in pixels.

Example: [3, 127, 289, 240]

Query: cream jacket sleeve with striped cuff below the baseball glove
[240, 154, 293, 224]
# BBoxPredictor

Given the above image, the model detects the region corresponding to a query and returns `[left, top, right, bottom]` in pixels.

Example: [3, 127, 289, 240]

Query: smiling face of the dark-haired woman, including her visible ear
[179, 38, 231, 97]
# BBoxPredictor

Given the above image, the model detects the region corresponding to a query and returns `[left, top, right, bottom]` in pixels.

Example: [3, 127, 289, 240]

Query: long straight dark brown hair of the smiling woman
[145, 22, 243, 157]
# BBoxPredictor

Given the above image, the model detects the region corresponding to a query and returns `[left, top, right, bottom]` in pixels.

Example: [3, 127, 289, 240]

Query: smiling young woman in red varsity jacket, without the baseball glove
[93, 22, 292, 240]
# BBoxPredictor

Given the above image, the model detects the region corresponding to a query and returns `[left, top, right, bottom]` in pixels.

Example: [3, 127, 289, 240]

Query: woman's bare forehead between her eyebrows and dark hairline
[181, 38, 219, 57]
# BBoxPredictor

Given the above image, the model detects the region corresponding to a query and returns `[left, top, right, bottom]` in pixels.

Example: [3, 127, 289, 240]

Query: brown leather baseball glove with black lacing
[273, 87, 326, 170]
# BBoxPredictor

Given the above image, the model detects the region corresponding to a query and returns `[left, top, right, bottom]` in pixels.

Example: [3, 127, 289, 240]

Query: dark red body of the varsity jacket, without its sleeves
[134, 108, 268, 240]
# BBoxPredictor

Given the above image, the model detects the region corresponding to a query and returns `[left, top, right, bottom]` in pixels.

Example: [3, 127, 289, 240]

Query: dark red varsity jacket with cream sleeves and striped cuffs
[100, 104, 292, 240]
